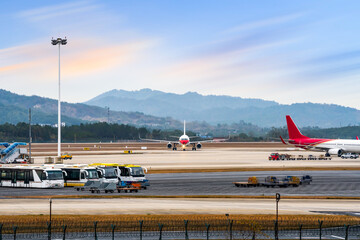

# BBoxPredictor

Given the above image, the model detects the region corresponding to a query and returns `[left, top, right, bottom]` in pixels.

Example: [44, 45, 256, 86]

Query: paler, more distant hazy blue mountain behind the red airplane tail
[85, 89, 360, 128]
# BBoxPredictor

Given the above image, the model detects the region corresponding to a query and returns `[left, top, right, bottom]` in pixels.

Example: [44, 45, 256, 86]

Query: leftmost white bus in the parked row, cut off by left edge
[0, 165, 64, 188]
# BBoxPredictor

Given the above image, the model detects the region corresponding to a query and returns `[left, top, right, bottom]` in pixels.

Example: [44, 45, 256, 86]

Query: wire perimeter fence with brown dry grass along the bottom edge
[0, 218, 360, 240]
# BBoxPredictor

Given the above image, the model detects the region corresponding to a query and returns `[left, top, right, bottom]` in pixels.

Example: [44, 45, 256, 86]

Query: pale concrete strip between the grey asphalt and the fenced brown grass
[0, 198, 360, 215]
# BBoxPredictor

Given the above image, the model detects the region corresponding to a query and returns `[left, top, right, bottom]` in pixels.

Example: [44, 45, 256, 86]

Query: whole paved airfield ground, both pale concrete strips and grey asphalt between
[0, 145, 360, 215]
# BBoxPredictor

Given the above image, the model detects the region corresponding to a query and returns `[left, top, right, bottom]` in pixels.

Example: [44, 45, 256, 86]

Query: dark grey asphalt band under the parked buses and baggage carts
[0, 171, 360, 198]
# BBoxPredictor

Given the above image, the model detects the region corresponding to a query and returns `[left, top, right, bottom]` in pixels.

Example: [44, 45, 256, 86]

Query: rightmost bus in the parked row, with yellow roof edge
[89, 163, 150, 189]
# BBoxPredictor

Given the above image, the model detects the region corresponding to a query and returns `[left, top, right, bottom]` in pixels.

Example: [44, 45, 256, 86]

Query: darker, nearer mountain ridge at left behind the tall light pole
[0, 89, 177, 128]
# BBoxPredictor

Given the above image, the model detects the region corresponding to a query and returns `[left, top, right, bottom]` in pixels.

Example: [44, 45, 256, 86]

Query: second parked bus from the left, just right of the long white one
[52, 164, 100, 187]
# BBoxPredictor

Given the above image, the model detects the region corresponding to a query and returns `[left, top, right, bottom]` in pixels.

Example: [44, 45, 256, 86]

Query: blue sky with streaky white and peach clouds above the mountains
[0, 0, 360, 109]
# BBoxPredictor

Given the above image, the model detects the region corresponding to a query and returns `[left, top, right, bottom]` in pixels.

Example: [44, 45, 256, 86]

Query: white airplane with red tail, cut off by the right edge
[280, 116, 360, 157]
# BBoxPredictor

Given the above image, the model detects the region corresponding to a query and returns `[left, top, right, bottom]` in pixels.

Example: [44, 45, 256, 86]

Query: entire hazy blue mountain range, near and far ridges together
[0, 89, 360, 132]
